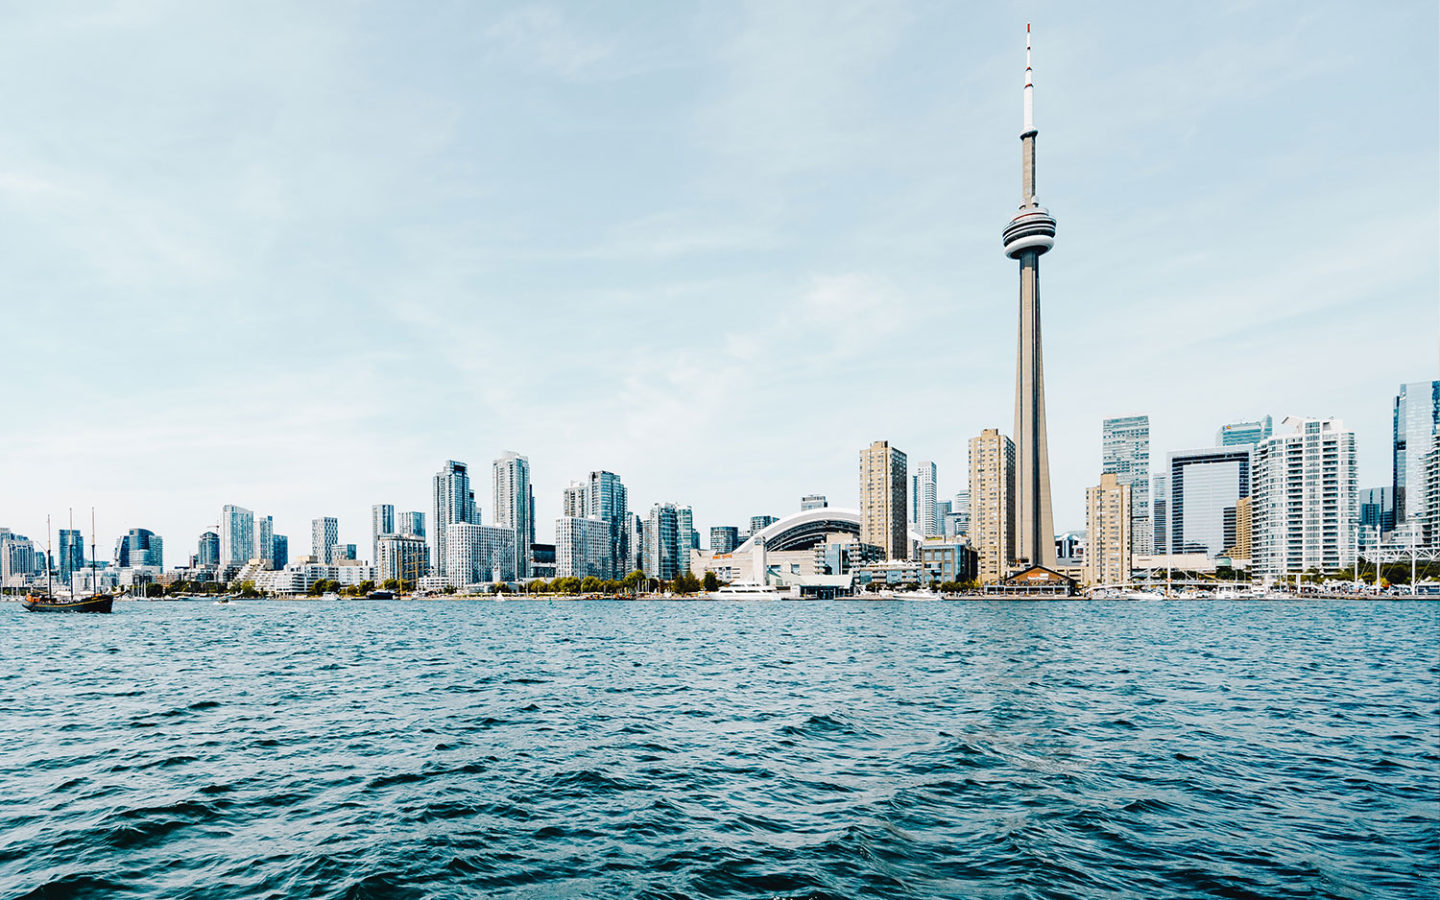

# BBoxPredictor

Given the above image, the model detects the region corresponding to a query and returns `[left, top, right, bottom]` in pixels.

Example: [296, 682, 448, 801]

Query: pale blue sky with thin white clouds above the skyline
[0, 0, 1440, 564]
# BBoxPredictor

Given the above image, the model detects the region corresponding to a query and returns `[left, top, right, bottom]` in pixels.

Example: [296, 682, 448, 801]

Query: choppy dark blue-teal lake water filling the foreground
[0, 602, 1440, 899]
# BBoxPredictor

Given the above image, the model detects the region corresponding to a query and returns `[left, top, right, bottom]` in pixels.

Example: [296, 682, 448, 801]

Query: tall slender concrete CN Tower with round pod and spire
[1004, 24, 1056, 569]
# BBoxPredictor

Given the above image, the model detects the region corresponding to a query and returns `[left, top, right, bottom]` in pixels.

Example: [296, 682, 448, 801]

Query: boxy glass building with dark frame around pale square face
[1168, 445, 1250, 559]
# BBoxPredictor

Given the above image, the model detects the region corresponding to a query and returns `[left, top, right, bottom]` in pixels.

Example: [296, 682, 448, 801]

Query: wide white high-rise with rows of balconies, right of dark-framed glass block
[1250, 418, 1359, 579]
